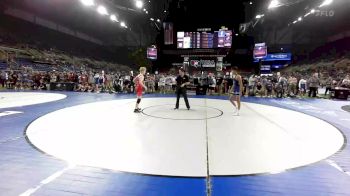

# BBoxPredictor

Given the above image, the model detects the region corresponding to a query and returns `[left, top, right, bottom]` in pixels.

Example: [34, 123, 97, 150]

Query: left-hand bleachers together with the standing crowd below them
[0, 32, 132, 92]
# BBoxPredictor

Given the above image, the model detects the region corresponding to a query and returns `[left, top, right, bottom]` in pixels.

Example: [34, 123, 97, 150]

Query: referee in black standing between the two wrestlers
[174, 68, 190, 110]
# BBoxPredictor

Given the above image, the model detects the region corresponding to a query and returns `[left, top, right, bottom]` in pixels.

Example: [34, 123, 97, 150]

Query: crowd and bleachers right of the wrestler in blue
[246, 55, 350, 97]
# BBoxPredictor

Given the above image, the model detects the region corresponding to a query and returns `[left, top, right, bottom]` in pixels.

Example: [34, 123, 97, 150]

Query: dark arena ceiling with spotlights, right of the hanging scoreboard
[247, 0, 350, 53]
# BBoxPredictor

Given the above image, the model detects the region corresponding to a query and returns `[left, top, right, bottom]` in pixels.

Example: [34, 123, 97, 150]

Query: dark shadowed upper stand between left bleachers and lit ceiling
[0, 15, 131, 64]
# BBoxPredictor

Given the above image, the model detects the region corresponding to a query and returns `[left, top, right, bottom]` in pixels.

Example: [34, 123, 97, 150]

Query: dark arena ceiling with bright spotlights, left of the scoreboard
[0, 0, 160, 47]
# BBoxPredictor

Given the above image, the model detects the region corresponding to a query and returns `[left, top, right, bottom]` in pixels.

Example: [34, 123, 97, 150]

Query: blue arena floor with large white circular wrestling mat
[0, 91, 350, 196]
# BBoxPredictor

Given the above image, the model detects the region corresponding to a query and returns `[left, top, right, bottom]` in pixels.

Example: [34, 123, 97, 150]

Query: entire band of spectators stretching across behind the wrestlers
[0, 54, 350, 98]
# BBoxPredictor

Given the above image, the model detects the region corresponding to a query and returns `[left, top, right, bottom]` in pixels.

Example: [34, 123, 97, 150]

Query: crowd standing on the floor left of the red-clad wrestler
[0, 64, 137, 92]
